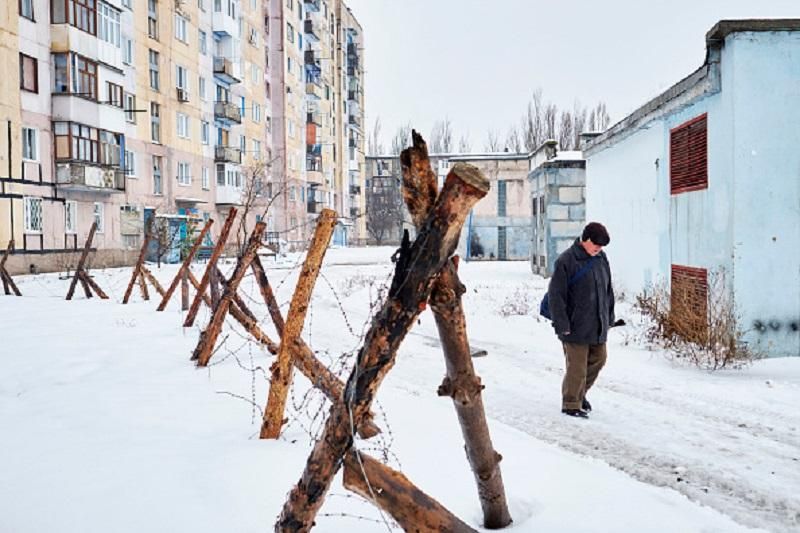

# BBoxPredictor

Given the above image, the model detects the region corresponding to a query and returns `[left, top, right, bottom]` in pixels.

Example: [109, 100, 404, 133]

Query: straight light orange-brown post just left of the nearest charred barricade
[261, 209, 336, 439]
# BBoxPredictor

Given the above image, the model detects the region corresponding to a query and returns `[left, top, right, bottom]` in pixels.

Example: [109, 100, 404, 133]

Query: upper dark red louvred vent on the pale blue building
[669, 113, 708, 194]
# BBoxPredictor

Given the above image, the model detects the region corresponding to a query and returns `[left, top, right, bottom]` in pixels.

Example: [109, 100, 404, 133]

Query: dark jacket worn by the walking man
[548, 239, 614, 344]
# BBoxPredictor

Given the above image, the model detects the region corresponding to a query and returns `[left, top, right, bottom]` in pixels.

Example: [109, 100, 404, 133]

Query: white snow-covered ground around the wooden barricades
[0, 248, 800, 533]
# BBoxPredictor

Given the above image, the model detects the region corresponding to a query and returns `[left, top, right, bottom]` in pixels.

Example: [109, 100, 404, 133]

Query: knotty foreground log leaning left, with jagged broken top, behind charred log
[400, 132, 511, 529]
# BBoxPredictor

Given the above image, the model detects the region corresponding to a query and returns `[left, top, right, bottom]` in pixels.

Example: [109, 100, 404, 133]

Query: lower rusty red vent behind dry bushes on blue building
[670, 265, 708, 340]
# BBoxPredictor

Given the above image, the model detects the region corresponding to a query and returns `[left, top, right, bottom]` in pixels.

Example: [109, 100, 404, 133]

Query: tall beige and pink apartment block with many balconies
[0, 0, 363, 272]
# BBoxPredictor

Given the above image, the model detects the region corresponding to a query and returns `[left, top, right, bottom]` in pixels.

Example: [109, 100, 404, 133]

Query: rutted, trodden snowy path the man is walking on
[397, 333, 800, 532]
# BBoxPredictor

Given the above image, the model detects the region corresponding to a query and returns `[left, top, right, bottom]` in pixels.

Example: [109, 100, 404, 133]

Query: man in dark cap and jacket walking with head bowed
[548, 222, 614, 418]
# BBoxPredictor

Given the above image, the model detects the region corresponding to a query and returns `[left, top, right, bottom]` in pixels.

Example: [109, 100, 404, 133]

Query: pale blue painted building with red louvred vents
[584, 19, 800, 356]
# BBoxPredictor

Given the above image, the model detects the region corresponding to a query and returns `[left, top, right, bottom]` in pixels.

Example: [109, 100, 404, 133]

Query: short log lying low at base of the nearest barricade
[344, 450, 477, 533]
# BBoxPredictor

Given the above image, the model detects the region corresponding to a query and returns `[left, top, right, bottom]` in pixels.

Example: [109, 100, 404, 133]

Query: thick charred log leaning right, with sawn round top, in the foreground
[275, 163, 489, 533]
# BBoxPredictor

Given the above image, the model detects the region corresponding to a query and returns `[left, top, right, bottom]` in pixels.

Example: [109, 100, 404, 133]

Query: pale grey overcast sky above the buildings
[347, 0, 800, 151]
